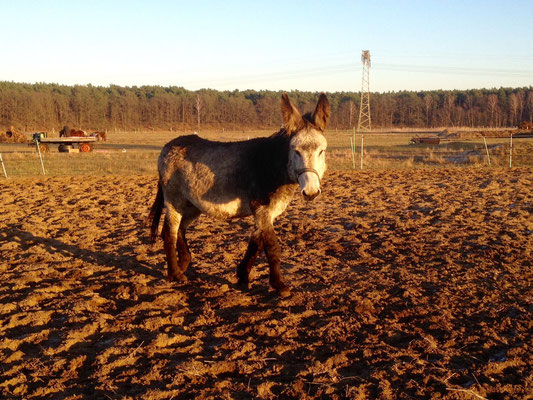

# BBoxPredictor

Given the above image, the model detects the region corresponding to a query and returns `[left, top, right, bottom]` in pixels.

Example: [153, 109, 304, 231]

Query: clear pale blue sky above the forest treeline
[0, 0, 533, 92]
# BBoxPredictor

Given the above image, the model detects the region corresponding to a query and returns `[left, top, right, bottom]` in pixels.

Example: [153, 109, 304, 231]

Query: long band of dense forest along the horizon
[0, 81, 533, 131]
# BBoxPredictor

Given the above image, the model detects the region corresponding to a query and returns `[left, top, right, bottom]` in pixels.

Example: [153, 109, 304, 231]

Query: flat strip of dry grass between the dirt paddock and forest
[0, 130, 533, 179]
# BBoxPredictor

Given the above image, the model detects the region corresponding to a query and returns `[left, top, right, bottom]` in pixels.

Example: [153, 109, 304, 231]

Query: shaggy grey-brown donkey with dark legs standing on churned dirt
[149, 93, 330, 297]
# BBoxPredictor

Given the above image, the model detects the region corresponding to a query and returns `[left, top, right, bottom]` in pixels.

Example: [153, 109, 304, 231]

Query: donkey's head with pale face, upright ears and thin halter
[281, 93, 330, 201]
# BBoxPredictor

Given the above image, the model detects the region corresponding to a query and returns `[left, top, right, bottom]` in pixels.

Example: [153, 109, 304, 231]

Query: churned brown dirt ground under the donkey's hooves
[0, 168, 533, 400]
